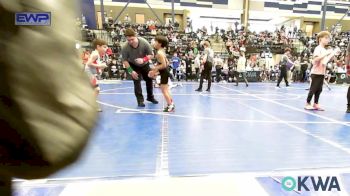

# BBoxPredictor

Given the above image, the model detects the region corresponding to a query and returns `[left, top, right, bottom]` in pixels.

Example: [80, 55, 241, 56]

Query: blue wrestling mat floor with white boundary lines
[15, 81, 350, 196]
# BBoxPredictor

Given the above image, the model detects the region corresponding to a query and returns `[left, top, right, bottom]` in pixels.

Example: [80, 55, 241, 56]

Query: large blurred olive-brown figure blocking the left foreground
[0, 0, 96, 196]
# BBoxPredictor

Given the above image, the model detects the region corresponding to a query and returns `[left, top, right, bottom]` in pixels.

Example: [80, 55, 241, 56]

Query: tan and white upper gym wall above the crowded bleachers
[91, 0, 350, 32]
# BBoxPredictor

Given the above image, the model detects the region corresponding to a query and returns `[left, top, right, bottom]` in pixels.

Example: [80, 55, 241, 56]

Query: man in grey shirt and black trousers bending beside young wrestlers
[122, 28, 158, 107]
